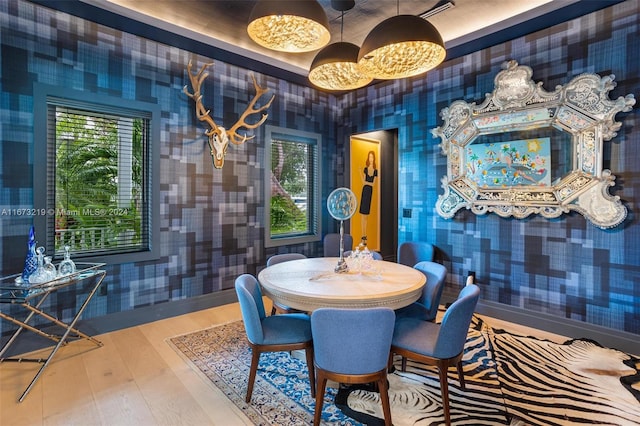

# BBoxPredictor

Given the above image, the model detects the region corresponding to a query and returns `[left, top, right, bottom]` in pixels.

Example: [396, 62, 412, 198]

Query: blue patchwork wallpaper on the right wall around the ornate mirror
[340, 0, 640, 334]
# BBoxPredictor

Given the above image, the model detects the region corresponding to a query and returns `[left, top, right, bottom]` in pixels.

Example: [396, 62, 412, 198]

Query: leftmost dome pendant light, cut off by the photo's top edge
[247, 0, 331, 53]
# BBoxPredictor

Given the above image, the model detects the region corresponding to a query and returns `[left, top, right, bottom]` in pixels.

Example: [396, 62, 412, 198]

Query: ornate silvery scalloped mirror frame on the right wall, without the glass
[432, 60, 635, 229]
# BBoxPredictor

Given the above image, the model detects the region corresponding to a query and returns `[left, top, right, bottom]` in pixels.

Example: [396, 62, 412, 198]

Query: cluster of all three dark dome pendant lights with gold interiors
[247, 0, 454, 91]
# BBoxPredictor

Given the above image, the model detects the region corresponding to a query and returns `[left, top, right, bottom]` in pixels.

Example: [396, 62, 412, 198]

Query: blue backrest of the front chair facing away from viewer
[311, 307, 395, 375]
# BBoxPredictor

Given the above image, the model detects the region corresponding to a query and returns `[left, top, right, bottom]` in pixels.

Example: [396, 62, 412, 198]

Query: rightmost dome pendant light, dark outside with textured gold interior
[358, 0, 446, 80]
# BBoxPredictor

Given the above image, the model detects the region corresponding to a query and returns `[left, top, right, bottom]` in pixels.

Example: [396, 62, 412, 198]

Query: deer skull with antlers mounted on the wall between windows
[182, 61, 275, 169]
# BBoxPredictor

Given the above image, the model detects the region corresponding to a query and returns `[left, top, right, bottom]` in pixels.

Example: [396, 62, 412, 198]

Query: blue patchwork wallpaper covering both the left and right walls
[0, 0, 640, 335]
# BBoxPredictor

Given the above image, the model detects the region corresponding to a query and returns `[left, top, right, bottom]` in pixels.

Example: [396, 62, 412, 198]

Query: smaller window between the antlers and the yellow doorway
[264, 126, 321, 247]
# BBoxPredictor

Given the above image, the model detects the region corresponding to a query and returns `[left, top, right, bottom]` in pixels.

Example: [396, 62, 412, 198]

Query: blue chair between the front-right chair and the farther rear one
[396, 261, 447, 321]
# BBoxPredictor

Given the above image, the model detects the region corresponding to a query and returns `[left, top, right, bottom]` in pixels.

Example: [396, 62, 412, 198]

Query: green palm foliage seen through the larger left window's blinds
[55, 107, 144, 253]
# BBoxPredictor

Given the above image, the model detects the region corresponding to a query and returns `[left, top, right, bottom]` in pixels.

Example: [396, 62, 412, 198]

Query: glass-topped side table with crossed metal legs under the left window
[0, 263, 107, 402]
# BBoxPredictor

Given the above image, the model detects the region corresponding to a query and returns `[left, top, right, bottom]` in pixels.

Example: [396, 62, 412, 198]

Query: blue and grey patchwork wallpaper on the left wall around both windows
[0, 0, 337, 327]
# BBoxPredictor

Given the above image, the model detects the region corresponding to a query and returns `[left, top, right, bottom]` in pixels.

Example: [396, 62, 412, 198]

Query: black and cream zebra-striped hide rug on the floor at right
[336, 318, 640, 426]
